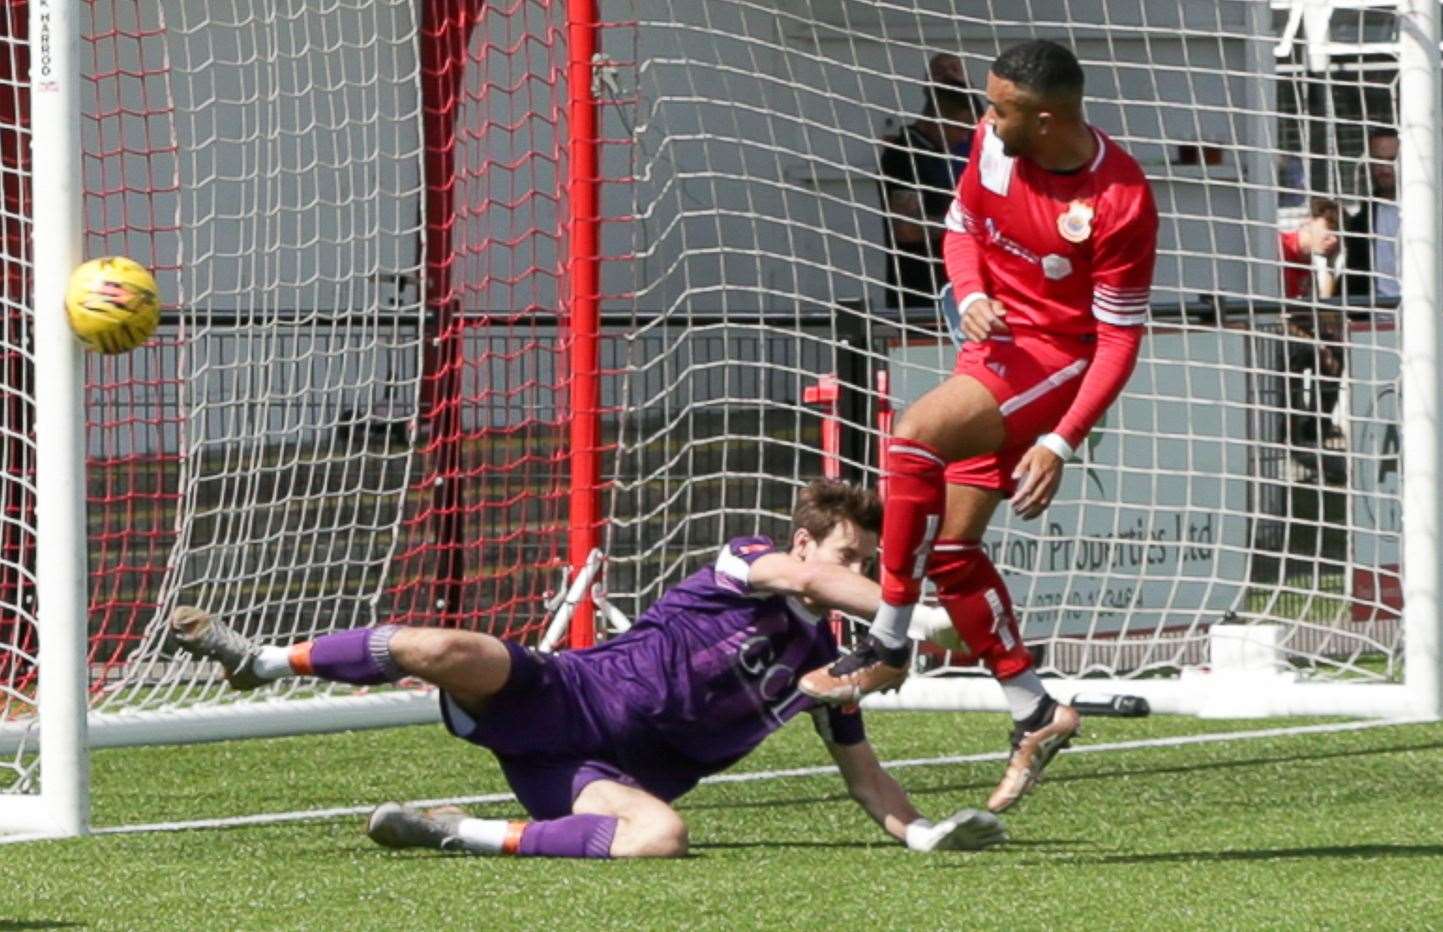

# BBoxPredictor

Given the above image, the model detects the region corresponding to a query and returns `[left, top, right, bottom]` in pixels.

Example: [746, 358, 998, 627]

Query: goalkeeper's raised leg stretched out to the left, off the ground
[170, 606, 511, 710]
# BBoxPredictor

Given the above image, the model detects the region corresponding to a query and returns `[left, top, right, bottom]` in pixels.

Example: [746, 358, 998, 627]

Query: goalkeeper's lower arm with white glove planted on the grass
[818, 730, 1007, 851]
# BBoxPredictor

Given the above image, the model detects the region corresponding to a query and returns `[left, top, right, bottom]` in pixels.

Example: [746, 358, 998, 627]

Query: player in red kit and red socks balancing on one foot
[799, 40, 1157, 811]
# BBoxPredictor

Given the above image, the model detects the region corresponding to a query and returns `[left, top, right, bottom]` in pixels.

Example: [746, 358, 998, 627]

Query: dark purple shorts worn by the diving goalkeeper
[442, 642, 696, 819]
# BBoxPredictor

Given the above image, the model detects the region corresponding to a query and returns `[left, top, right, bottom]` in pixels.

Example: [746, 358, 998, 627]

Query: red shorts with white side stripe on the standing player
[947, 333, 1095, 498]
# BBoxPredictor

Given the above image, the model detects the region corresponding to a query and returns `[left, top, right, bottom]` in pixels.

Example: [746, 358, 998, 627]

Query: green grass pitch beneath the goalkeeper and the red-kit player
[8, 713, 1443, 931]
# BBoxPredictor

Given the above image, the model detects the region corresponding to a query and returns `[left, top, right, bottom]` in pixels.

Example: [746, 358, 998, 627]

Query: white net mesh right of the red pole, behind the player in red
[610, 0, 1401, 678]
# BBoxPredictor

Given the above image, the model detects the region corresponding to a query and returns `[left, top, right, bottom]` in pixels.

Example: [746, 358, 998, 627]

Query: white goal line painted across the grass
[0, 718, 1427, 844]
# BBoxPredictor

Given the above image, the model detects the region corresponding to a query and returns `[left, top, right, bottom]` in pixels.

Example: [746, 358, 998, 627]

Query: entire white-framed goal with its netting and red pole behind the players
[0, 0, 1443, 835]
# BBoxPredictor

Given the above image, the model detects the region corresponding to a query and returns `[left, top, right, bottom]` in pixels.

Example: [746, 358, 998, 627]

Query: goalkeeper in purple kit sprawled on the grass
[172, 479, 1006, 858]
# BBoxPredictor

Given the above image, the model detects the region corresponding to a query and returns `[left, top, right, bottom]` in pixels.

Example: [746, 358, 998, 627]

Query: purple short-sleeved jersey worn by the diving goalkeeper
[557, 537, 863, 782]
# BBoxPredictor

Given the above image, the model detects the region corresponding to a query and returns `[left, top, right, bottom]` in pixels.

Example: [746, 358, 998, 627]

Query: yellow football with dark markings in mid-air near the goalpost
[65, 255, 160, 353]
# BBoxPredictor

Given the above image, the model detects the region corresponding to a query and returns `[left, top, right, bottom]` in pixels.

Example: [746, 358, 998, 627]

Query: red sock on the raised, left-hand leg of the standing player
[869, 440, 947, 648]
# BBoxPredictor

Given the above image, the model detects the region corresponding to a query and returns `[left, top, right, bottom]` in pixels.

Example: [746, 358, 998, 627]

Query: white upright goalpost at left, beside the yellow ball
[0, 3, 89, 835]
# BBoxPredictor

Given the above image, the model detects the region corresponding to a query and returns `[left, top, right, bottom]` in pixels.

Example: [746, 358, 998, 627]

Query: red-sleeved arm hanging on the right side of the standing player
[1012, 177, 1157, 518]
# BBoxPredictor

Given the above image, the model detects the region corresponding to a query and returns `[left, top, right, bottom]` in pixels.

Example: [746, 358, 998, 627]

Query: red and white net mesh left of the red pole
[8, 0, 585, 785]
